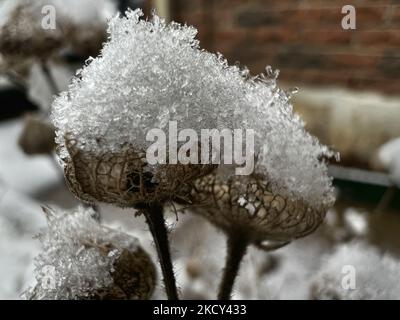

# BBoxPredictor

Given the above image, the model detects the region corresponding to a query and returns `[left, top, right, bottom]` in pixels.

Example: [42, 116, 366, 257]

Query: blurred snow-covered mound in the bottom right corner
[311, 242, 400, 300]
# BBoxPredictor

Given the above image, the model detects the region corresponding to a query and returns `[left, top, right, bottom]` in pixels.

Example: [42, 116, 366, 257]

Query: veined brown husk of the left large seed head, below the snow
[63, 137, 215, 208]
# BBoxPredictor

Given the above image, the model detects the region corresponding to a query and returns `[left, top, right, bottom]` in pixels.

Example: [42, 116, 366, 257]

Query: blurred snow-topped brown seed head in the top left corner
[0, 0, 116, 60]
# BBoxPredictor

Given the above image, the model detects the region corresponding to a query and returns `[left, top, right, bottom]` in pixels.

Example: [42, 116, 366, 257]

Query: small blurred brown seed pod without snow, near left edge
[18, 114, 56, 155]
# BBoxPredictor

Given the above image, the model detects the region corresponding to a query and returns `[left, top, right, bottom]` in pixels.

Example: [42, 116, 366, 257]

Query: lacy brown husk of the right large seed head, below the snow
[192, 174, 327, 248]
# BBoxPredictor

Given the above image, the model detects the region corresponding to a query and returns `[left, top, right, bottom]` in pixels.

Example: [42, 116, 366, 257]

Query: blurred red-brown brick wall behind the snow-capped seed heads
[170, 0, 400, 94]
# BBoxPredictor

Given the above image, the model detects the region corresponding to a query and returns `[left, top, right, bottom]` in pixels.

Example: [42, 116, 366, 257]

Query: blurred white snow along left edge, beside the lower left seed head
[0, 121, 62, 299]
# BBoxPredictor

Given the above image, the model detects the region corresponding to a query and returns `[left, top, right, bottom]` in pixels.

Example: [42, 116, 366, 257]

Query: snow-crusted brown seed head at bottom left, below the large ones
[25, 207, 155, 300]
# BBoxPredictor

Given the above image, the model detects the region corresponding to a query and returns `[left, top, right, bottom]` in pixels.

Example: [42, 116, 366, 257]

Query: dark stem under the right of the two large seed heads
[218, 234, 249, 300]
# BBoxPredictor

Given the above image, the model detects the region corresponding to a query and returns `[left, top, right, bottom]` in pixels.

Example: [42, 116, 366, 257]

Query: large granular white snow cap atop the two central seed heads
[52, 10, 333, 210]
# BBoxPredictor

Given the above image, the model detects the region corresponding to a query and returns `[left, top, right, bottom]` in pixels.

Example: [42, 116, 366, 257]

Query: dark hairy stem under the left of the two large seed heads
[142, 204, 178, 300]
